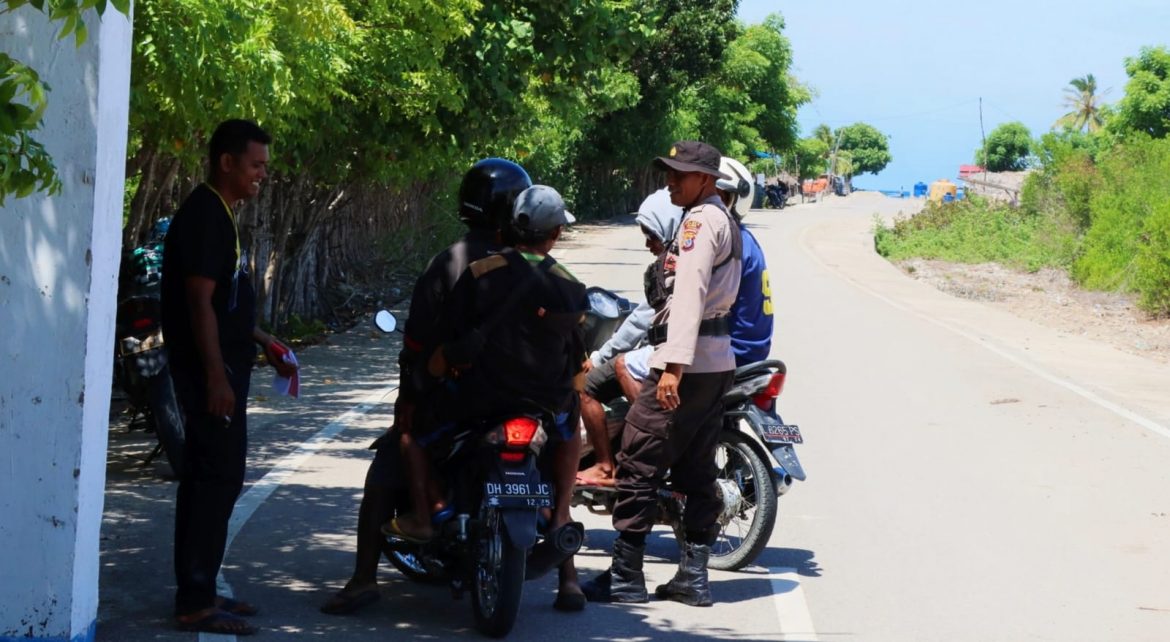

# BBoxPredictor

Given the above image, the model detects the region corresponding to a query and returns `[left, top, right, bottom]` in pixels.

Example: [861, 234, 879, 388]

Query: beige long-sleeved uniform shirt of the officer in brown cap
[651, 195, 742, 372]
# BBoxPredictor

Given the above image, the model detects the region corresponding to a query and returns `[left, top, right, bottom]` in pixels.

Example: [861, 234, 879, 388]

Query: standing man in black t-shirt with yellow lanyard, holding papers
[163, 120, 296, 635]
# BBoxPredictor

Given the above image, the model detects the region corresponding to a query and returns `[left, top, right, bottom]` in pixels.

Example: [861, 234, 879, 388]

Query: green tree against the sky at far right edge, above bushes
[1110, 47, 1170, 138]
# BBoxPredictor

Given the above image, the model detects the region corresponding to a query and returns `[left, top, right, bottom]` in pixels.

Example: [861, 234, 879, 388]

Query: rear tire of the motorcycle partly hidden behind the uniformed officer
[708, 430, 777, 571]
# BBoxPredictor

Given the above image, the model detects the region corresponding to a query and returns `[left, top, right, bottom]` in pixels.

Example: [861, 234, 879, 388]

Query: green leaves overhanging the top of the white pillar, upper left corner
[0, 0, 130, 206]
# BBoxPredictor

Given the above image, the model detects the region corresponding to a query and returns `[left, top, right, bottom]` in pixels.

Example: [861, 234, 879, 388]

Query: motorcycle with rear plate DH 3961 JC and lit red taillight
[376, 311, 584, 637]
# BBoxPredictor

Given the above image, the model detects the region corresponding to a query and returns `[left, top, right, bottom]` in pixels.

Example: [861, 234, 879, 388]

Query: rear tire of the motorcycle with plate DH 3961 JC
[472, 505, 527, 637]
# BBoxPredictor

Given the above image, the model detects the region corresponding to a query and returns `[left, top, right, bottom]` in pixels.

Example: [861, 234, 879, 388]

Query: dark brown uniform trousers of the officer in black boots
[613, 371, 735, 533]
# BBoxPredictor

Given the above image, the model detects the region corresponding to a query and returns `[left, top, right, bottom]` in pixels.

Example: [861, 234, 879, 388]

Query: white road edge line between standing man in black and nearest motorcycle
[199, 381, 398, 642]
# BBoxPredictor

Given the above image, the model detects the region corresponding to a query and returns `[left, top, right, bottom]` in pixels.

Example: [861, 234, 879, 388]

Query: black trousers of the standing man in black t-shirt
[172, 364, 252, 614]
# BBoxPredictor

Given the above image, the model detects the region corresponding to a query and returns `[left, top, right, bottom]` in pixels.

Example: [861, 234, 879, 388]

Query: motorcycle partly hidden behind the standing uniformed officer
[573, 288, 805, 571]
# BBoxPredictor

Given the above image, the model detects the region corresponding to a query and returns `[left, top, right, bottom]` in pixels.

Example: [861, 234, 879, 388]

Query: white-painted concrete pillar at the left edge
[0, 6, 131, 641]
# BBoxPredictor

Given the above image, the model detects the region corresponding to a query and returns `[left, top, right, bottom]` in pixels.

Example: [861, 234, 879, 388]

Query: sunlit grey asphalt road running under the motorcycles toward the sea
[97, 194, 1170, 641]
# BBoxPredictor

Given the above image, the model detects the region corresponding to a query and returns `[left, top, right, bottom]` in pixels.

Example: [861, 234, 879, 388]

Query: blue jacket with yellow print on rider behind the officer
[728, 223, 772, 367]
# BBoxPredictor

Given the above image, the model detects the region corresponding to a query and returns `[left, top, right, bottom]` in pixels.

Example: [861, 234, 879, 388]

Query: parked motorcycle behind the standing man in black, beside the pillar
[113, 235, 185, 477]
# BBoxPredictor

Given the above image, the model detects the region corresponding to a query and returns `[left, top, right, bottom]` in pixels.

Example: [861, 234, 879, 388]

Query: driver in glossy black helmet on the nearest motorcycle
[321, 158, 532, 615]
